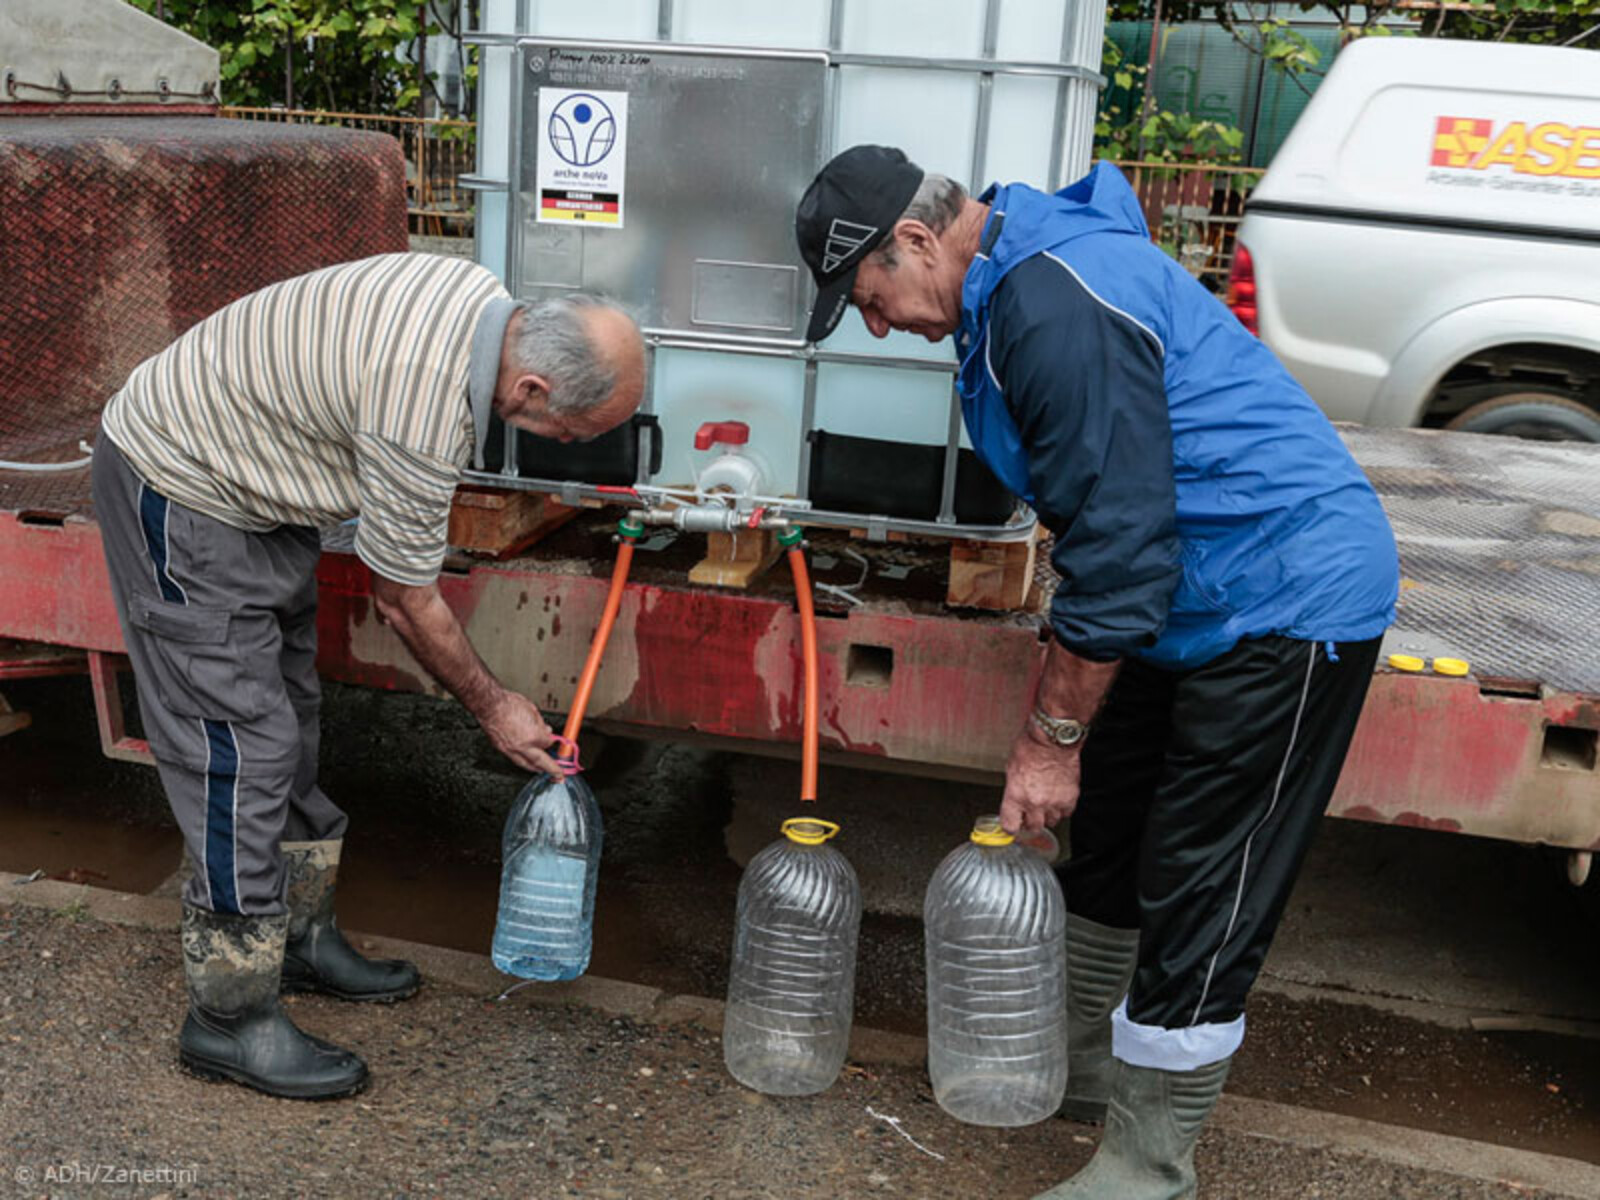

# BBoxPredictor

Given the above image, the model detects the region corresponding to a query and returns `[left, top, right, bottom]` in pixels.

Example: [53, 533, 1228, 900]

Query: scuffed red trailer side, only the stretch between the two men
[317, 534, 1042, 770]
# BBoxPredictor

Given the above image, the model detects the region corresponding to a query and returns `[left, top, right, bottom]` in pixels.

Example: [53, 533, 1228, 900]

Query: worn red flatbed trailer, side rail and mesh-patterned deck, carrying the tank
[0, 429, 1600, 850]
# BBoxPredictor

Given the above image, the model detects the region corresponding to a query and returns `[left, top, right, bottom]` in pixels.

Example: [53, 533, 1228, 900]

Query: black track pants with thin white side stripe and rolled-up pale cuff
[1061, 637, 1379, 1070]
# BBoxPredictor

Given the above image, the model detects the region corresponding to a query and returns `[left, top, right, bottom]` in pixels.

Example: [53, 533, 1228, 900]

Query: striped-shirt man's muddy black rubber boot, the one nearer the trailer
[283, 842, 422, 1003]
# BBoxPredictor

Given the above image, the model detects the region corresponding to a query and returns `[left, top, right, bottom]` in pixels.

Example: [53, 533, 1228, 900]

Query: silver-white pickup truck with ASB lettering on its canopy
[1229, 38, 1600, 442]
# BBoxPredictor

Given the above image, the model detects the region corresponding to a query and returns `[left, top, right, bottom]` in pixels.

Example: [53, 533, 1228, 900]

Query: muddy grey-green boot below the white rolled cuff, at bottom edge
[1034, 1058, 1232, 1200]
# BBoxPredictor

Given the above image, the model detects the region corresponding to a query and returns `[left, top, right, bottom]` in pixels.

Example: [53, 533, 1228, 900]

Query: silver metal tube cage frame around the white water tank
[462, 0, 1106, 541]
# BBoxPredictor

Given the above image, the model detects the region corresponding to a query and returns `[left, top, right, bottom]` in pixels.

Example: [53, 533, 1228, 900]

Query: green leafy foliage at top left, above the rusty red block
[128, 0, 440, 114]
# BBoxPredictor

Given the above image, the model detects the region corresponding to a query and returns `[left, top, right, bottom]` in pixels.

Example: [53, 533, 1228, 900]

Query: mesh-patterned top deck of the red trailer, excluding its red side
[0, 426, 1600, 696]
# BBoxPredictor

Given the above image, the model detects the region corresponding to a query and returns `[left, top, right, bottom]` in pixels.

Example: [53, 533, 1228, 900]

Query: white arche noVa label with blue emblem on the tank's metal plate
[536, 88, 627, 229]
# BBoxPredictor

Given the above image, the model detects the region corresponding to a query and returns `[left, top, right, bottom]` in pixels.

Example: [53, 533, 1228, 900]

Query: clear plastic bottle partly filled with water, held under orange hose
[493, 774, 603, 979]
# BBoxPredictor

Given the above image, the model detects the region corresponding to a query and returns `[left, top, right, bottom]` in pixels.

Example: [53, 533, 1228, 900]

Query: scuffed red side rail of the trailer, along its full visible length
[0, 502, 1600, 848]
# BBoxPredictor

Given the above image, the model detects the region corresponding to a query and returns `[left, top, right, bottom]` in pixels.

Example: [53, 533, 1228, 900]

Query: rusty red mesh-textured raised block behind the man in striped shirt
[0, 117, 406, 512]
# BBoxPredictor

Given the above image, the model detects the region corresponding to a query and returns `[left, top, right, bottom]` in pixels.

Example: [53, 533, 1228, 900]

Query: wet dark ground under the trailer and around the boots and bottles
[0, 680, 1600, 1200]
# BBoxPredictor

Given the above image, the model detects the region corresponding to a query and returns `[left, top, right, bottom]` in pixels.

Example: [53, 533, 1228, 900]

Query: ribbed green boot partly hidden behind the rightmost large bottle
[1061, 912, 1139, 1125]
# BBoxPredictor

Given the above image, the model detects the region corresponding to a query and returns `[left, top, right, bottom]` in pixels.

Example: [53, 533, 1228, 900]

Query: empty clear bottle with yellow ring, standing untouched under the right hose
[722, 818, 861, 1096]
